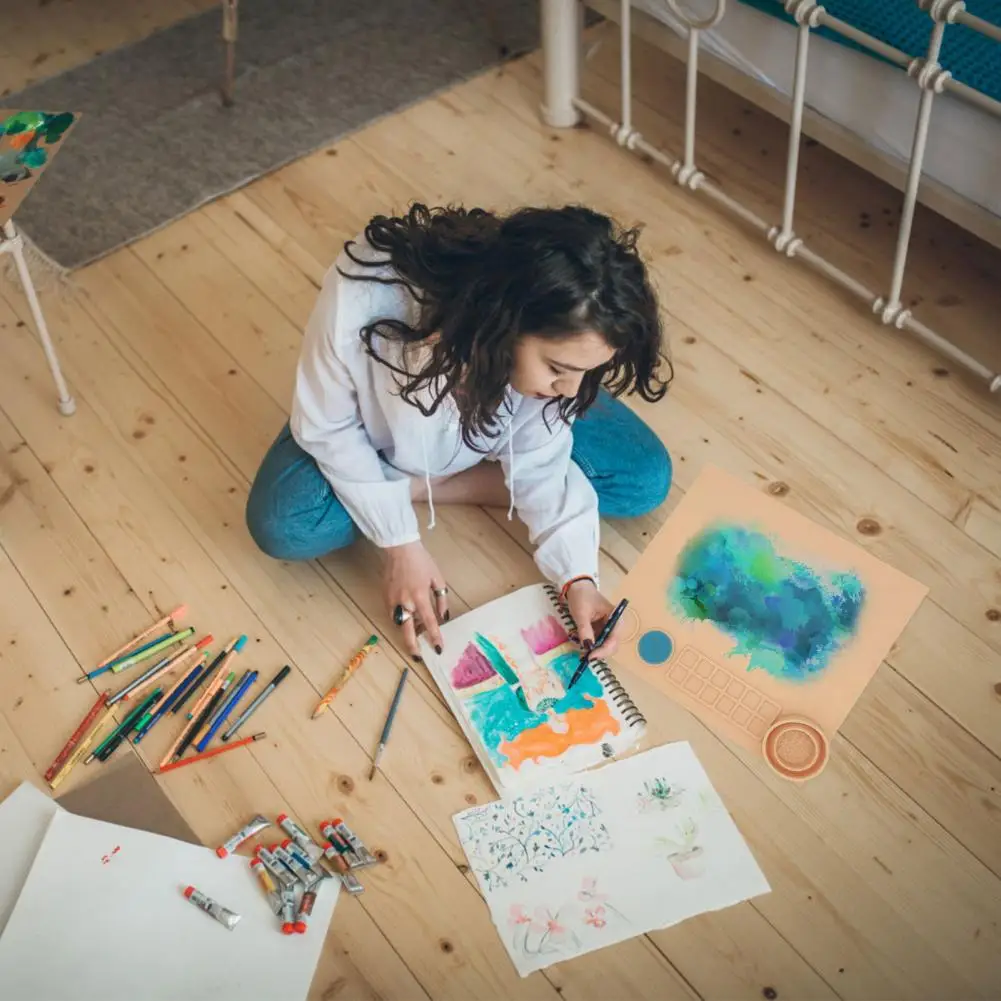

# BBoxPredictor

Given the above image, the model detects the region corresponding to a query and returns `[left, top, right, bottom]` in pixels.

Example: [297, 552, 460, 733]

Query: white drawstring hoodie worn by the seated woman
[290, 240, 599, 586]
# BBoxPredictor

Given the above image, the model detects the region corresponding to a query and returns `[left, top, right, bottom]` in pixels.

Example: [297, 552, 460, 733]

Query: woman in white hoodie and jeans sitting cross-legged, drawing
[247, 204, 671, 660]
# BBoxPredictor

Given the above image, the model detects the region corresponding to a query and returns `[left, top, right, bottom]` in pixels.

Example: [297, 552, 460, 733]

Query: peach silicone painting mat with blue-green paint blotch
[616, 467, 928, 751]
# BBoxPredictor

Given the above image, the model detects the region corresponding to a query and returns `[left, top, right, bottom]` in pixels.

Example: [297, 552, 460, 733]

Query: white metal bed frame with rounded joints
[541, 0, 1001, 393]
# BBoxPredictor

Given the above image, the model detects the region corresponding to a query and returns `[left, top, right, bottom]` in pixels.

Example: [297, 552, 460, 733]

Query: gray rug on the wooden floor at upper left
[3, 0, 539, 268]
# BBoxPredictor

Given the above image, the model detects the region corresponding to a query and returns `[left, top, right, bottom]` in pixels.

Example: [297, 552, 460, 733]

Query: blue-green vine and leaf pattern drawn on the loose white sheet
[455, 785, 612, 891]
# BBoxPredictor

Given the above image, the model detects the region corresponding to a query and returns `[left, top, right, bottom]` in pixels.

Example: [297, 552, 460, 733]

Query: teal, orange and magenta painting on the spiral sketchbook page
[448, 615, 623, 771]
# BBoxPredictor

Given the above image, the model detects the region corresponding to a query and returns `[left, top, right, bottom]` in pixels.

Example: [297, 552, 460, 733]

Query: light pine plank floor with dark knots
[0, 3, 1001, 1001]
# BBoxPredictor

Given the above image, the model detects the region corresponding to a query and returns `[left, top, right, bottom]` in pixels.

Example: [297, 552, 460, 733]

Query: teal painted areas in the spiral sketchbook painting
[465, 651, 604, 767]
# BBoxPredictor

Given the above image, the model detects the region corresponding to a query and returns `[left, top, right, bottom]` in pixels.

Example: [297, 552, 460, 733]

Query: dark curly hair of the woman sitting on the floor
[342, 204, 673, 448]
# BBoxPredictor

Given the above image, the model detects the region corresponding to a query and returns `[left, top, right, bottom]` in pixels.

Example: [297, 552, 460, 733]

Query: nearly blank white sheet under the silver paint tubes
[0, 812, 338, 1001]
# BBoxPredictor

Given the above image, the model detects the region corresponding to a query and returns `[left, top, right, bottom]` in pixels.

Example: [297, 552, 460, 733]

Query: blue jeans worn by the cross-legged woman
[246, 392, 672, 560]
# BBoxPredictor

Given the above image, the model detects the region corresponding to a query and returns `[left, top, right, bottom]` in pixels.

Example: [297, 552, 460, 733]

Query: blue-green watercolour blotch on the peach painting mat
[668, 524, 866, 682]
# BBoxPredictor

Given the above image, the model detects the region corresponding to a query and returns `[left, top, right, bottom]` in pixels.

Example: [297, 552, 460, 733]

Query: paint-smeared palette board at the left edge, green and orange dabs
[0, 109, 79, 225]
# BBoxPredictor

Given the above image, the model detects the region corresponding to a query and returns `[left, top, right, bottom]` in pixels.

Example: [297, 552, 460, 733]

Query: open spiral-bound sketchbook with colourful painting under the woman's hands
[422, 585, 647, 793]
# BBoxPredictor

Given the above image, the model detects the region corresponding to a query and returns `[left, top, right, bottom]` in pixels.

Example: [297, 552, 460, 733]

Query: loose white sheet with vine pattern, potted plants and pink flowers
[453, 743, 769, 977]
